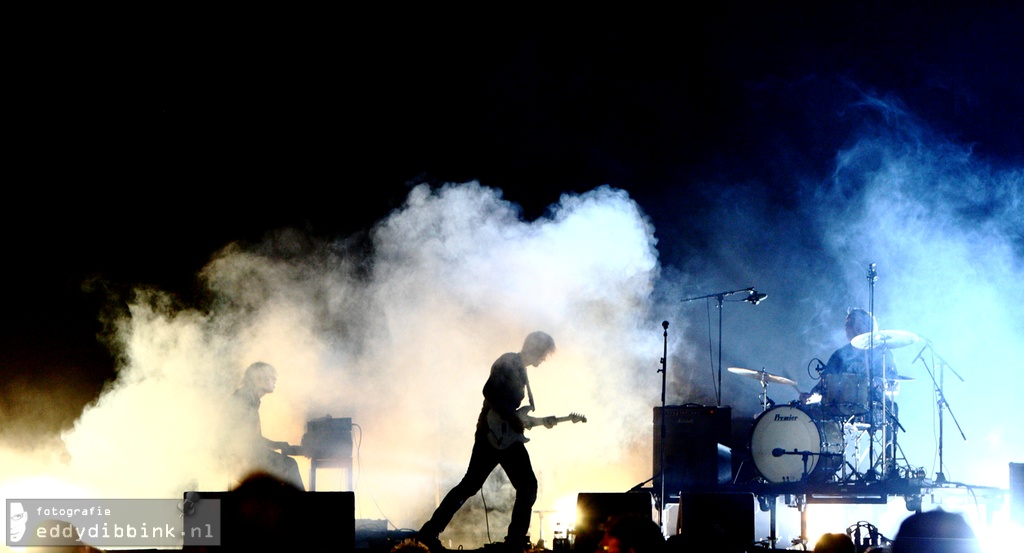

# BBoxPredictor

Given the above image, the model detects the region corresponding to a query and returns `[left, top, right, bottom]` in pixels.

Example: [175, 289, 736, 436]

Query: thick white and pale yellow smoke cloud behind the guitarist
[2, 182, 658, 540]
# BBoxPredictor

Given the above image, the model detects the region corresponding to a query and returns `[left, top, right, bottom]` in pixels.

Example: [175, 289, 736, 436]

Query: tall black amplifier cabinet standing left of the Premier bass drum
[653, 406, 732, 495]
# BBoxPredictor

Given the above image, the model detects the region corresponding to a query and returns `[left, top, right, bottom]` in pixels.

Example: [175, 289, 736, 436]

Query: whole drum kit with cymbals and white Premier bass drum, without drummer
[728, 330, 920, 482]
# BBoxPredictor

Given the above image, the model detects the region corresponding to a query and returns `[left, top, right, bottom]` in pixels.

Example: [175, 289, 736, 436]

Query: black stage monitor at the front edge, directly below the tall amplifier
[673, 493, 755, 553]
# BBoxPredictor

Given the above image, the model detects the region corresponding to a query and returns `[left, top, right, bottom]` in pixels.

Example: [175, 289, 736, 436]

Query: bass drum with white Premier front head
[751, 406, 846, 482]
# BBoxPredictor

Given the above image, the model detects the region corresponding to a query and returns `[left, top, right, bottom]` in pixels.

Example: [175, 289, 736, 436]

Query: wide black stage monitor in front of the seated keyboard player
[185, 482, 355, 551]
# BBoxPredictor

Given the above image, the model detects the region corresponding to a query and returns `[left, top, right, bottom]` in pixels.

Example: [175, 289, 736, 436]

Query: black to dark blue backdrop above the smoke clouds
[0, 2, 1024, 436]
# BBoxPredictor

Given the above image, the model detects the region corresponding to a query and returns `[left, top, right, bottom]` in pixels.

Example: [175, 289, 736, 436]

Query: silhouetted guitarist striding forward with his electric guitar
[418, 331, 586, 553]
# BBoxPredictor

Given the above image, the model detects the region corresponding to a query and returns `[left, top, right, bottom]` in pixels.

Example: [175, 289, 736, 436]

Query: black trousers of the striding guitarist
[420, 434, 537, 541]
